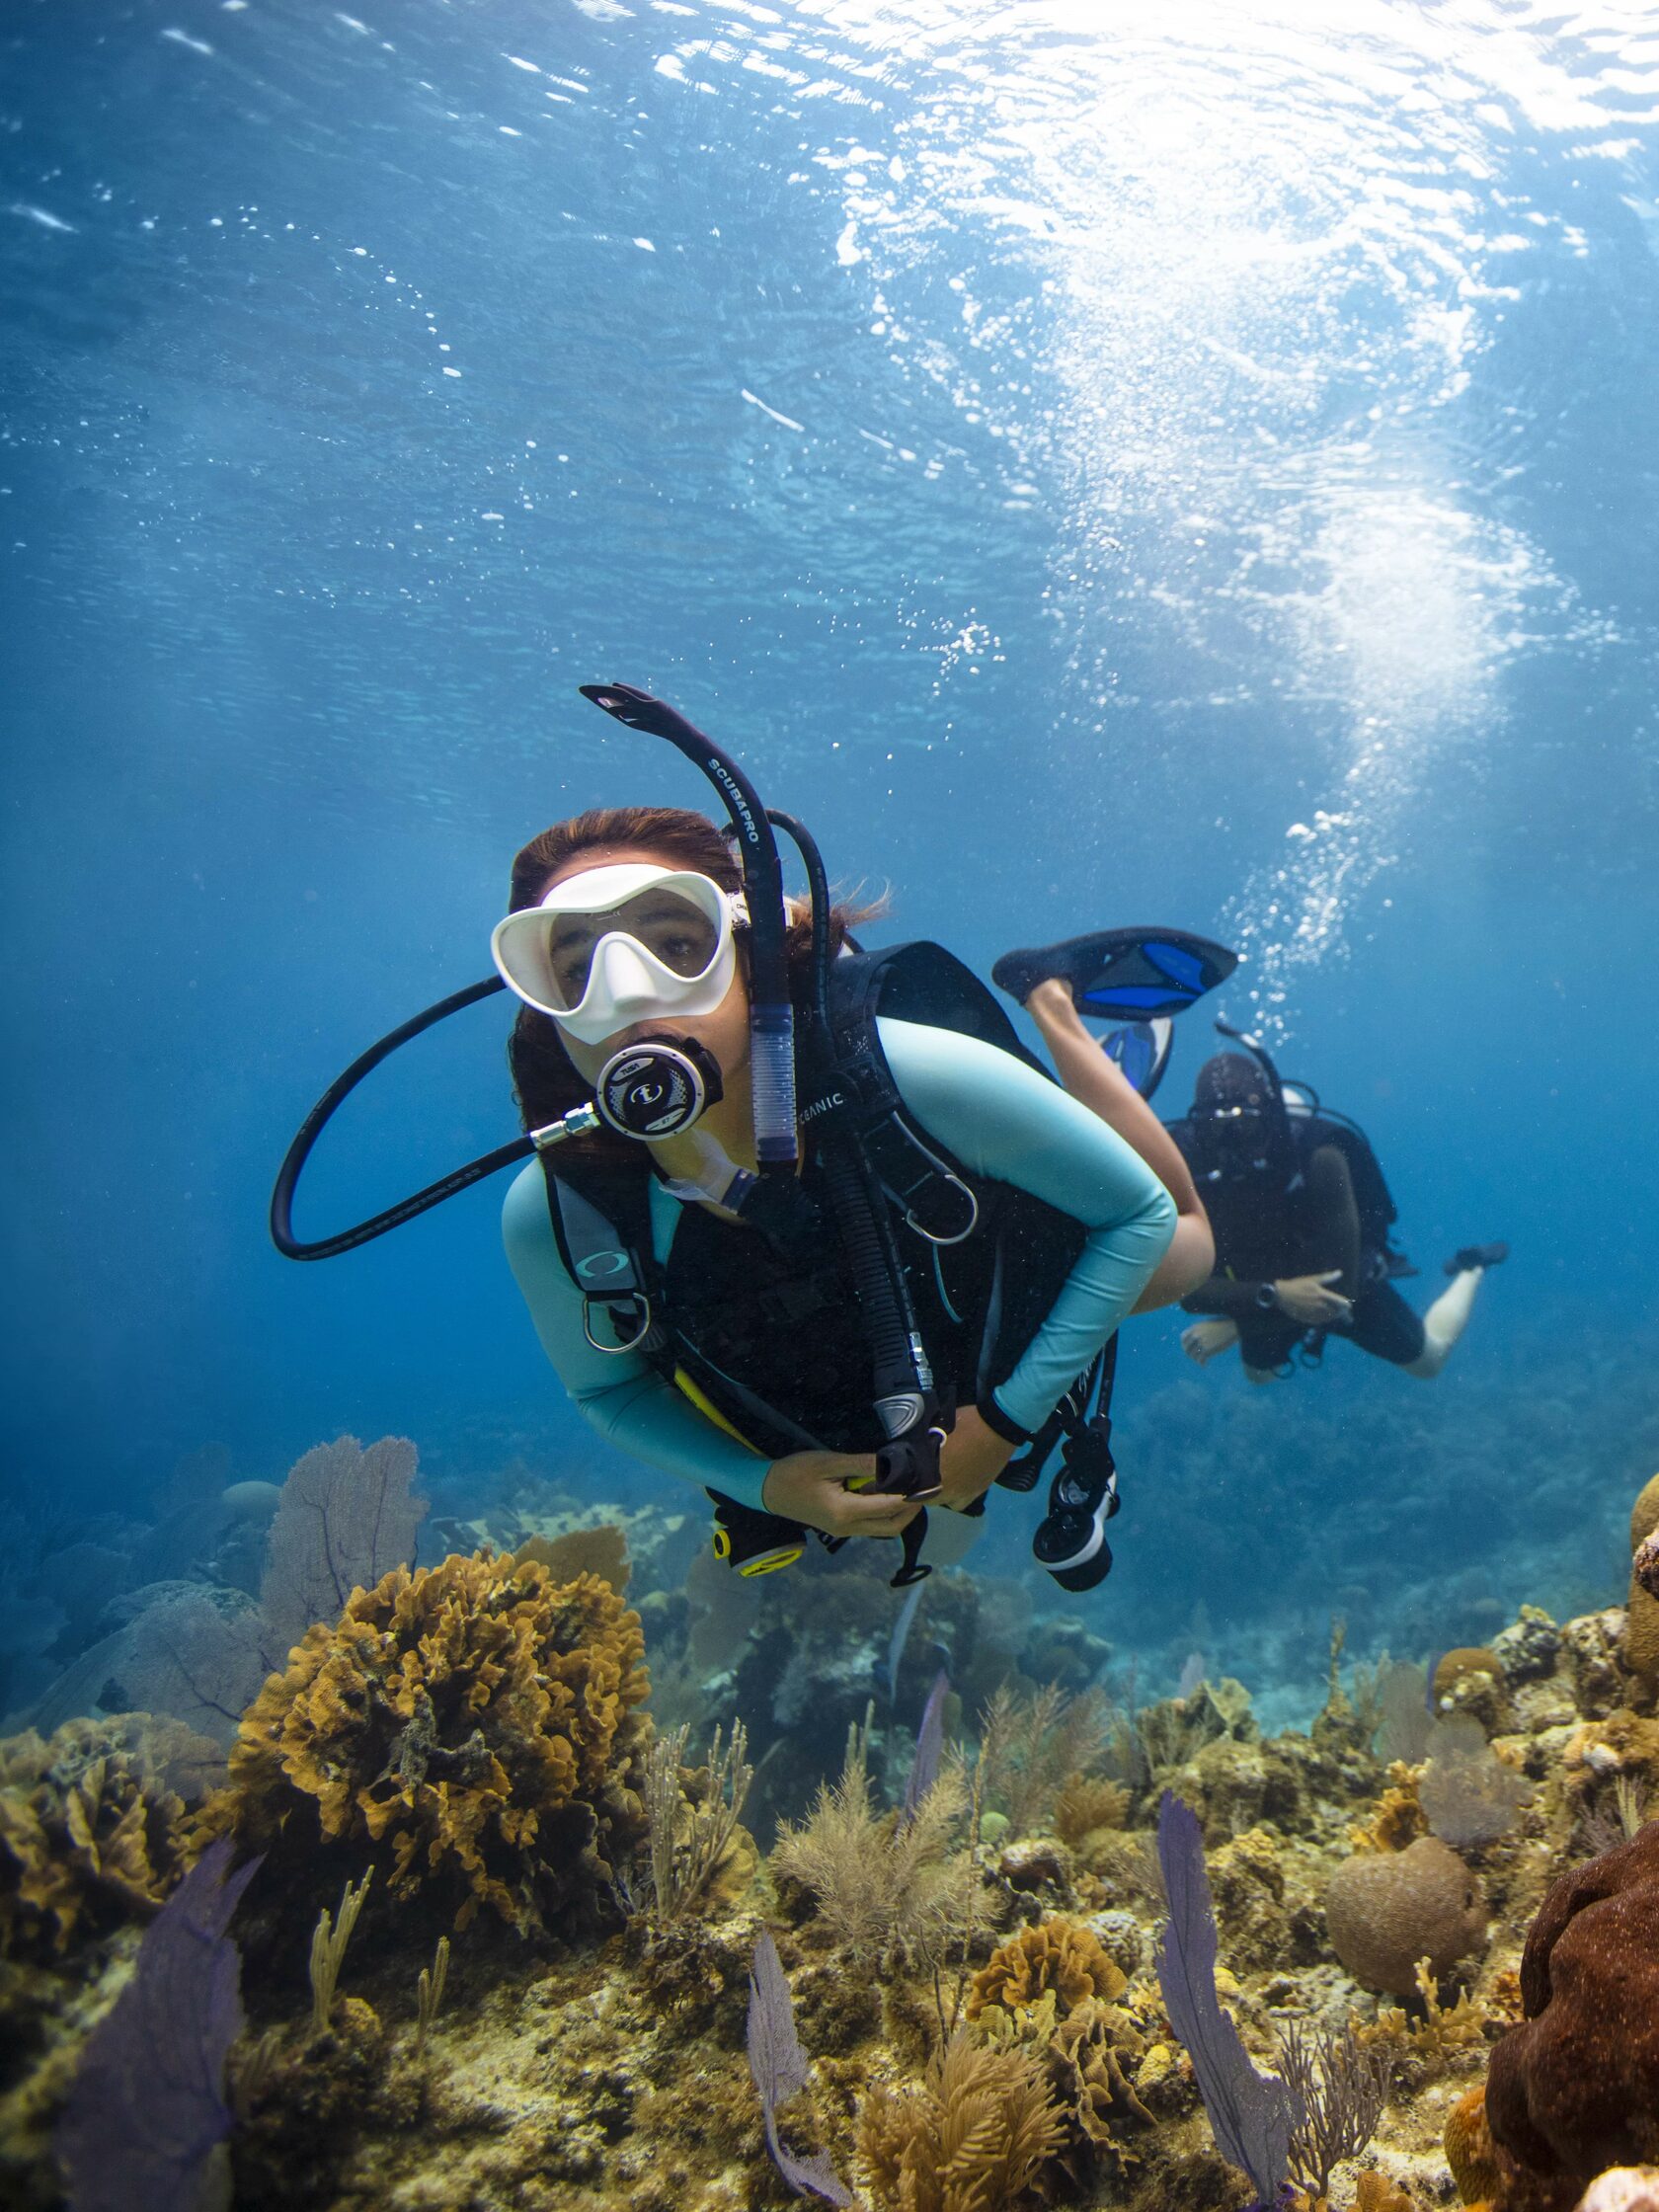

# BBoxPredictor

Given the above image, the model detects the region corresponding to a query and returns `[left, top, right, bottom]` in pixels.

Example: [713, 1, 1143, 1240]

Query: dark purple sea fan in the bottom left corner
[57, 1843, 259, 2212]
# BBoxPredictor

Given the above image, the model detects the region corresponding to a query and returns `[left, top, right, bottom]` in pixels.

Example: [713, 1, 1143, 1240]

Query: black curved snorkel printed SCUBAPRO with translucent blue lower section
[578, 683, 801, 1174]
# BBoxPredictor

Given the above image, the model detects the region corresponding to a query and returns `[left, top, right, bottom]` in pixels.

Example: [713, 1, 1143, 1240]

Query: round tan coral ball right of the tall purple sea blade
[1325, 1836, 1486, 1998]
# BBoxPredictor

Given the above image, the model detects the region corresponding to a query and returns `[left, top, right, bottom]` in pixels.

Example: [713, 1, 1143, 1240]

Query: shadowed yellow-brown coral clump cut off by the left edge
[0, 1712, 217, 1955]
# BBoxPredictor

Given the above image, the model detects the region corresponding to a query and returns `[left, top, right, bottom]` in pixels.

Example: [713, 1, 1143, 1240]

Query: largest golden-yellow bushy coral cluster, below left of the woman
[205, 1552, 651, 1929]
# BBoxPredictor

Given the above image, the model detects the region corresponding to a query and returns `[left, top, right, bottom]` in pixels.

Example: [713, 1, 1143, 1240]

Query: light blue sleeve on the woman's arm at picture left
[502, 1159, 772, 1513]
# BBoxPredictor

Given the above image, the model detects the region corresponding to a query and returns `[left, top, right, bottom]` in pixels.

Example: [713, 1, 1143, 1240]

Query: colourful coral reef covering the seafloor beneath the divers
[16, 1413, 1659, 2212]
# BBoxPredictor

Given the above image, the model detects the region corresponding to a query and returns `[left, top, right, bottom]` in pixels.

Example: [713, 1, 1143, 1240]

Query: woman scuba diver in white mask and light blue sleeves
[270, 683, 1234, 1591]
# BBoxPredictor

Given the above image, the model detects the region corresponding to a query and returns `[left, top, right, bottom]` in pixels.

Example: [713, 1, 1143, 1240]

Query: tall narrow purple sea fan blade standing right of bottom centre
[1157, 1789, 1303, 2205]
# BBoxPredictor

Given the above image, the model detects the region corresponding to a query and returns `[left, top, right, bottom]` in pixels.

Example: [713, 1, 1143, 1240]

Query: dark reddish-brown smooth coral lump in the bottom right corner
[1486, 1823, 1659, 2208]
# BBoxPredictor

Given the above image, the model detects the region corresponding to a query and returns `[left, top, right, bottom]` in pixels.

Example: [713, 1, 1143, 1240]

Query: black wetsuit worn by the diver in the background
[1170, 1122, 1425, 1372]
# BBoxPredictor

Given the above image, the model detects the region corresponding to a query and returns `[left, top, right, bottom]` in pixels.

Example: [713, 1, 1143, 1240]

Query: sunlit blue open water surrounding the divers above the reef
[0, 0, 1659, 1707]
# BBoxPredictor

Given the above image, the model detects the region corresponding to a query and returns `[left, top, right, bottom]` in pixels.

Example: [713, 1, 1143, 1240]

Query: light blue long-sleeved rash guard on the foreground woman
[502, 1017, 1174, 1511]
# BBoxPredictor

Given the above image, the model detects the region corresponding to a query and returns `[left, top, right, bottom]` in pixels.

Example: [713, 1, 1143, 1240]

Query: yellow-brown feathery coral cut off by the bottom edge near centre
[858, 2035, 1062, 2212]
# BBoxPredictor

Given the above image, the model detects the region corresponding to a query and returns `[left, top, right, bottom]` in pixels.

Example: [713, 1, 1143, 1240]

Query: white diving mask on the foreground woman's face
[489, 860, 748, 1044]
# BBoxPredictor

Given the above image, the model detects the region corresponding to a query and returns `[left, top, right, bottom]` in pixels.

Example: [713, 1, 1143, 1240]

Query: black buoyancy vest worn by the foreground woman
[542, 940, 1086, 1458]
